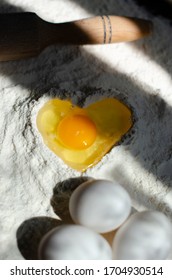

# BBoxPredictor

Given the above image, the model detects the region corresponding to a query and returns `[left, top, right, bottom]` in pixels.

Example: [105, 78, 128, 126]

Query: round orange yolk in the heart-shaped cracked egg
[57, 114, 97, 150]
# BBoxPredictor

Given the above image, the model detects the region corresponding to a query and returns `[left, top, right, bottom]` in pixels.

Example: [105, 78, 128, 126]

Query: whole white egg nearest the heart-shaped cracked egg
[69, 180, 131, 233]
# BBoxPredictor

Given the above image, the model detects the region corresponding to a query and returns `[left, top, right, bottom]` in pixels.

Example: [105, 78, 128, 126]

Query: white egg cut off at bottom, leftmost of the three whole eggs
[39, 225, 112, 260]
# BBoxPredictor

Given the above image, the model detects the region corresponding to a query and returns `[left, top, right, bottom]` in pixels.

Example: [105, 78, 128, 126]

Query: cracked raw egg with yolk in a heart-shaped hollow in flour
[37, 98, 132, 171]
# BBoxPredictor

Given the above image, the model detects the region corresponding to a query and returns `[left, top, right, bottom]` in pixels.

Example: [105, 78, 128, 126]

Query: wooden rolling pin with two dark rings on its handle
[0, 13, 152, 61]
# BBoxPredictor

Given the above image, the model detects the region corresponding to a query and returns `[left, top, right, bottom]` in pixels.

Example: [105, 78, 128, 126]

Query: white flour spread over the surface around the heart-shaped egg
[0, 0, 172, 259]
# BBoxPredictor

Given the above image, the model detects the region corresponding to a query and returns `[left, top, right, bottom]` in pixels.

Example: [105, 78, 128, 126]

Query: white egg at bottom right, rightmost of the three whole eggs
[112, 211, 172, 260]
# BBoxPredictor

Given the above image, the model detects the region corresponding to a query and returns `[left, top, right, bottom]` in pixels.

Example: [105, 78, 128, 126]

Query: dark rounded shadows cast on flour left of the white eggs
[16, 177, 92, 260]
